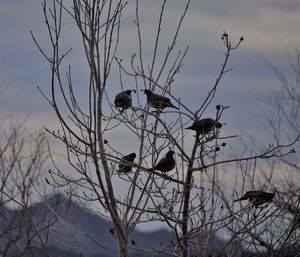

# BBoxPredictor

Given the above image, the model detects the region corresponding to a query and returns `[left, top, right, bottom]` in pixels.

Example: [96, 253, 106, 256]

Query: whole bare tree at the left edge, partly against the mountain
[0, 121, 49, 256]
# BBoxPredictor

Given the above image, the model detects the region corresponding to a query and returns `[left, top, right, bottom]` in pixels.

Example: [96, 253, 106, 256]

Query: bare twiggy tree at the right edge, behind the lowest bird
[211, 48, 300, 256]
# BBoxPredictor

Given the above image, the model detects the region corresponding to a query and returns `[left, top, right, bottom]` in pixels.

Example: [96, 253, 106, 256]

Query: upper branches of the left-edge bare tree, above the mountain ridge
[0, 118, 48, 208]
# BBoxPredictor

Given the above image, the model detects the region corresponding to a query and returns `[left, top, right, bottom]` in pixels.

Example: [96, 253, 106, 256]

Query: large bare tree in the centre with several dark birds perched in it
[32, 0, 298, 257]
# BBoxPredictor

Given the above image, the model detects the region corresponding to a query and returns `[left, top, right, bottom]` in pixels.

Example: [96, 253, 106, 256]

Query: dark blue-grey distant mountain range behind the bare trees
[0, 194, 239, 257]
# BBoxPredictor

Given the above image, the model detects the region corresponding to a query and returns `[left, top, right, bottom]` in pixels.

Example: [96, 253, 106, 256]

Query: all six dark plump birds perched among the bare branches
[115, 89, 275, 208]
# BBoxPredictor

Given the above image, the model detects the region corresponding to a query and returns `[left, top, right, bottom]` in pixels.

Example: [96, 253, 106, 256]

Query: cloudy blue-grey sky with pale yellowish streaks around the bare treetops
[0, 0, 300, 216]
